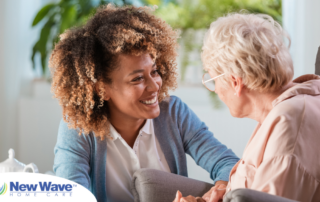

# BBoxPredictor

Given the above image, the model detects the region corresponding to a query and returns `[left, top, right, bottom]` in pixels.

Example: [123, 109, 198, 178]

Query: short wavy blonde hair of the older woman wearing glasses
[201, 13, 293, 92]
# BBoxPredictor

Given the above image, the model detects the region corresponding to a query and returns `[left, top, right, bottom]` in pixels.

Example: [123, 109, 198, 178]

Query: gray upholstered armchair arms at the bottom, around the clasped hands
[131, 169, 296, 202]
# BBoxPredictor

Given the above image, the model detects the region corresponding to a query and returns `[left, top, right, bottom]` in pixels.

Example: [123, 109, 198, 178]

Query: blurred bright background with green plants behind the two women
[0, 0, 320, 182]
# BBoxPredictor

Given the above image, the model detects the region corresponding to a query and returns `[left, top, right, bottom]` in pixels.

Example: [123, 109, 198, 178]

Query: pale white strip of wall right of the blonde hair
[282, 0, 320, 78]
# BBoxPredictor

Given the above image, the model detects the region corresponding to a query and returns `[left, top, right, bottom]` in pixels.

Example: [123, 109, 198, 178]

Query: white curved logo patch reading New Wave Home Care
[0, 172, 97, 202]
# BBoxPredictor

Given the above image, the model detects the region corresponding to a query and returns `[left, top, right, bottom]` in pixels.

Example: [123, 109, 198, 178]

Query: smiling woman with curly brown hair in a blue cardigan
[50, 5, 239, 202]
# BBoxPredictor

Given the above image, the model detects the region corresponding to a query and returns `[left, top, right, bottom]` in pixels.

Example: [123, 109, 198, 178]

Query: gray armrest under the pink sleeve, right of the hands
[223, 189, 297, 202]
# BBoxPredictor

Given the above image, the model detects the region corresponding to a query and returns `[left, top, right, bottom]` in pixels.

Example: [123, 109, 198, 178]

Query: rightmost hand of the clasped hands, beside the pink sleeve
[201, 181, 227, 202]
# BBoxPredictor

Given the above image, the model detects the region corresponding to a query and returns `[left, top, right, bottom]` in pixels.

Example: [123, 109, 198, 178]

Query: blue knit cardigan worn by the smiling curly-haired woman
[53, 96, 239, 202]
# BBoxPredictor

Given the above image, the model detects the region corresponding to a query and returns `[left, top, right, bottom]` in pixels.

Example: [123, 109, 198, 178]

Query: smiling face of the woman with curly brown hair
[107, 54, 162, 119]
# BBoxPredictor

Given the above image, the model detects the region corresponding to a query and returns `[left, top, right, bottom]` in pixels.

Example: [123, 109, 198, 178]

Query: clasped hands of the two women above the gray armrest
[173, 181, 227, 202]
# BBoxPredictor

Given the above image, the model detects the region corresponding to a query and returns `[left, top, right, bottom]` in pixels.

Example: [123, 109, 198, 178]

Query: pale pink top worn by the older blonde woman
[227, 75, 320, 201]
